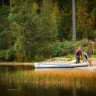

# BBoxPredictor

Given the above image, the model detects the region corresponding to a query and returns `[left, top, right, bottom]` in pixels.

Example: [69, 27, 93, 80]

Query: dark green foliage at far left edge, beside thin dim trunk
[0, 5, 9, 50]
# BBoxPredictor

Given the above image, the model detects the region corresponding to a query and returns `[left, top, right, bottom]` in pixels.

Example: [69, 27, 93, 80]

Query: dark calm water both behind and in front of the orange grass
[0, 66, 96, 96]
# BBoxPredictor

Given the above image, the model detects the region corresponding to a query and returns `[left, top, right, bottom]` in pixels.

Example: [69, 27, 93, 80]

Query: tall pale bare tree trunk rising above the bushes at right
[72, 0, 76, 41]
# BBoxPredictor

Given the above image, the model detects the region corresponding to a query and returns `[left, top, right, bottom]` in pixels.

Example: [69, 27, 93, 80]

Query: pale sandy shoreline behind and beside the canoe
[0, 57, 96, 71]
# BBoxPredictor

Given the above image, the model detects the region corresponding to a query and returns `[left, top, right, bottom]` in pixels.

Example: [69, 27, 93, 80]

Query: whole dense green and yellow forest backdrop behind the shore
[0, 0, 96, 61]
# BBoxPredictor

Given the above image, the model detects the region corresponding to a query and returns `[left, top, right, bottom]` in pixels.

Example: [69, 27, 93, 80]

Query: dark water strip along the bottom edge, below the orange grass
[0, 86, 96, 96]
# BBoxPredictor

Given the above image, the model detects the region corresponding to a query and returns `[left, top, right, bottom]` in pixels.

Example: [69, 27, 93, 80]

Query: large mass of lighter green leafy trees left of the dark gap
[9, 0, 58, 61]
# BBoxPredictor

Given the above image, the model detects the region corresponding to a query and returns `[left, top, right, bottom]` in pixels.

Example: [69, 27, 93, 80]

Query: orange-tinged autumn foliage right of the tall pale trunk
[76, 0, 96, 40]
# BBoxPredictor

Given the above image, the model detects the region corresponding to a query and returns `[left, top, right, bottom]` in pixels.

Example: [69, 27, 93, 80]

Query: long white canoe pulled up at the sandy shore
[35, 61, 90, 68]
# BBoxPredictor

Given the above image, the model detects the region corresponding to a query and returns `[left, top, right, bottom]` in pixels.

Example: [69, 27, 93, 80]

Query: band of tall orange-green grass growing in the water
[0, 70, 96, 89]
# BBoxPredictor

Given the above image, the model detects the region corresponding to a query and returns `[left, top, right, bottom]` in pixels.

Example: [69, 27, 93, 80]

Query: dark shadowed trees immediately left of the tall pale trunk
[57, 0, 72, 41]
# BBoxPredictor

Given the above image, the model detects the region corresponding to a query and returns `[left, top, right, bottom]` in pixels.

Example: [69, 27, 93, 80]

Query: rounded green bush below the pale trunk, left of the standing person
[51, 41, 75, 57]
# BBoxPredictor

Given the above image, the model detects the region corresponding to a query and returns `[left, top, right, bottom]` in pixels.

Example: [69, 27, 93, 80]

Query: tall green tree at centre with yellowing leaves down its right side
[39, 0, 59, 57]
